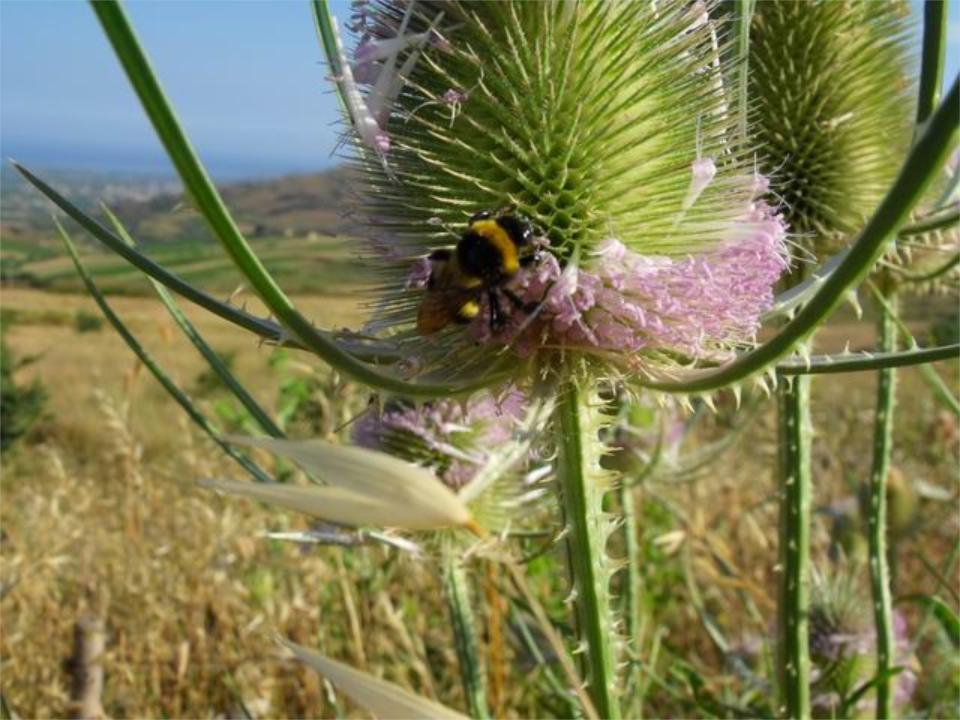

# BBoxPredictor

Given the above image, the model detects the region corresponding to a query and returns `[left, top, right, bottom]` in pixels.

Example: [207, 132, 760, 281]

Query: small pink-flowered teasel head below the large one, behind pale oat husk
[353, 388, 551, 532]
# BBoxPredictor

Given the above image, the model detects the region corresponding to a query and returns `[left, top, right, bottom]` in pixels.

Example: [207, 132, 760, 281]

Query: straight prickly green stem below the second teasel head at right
[778, 376, 812, 720]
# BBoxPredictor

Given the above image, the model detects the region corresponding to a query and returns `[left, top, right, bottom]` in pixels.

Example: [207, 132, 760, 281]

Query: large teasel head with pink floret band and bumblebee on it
[326, 0, 787, 388]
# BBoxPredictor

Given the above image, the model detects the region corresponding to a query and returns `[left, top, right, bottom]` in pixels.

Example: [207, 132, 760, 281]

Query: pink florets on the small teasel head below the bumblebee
[353, 391, 526, 490]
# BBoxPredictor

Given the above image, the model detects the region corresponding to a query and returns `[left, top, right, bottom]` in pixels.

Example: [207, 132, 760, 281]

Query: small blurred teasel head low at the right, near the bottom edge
[809, 563, 917, 717]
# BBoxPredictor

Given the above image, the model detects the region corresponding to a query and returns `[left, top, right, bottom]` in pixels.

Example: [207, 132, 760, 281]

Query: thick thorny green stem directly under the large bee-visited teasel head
[555, 380, 620, 718]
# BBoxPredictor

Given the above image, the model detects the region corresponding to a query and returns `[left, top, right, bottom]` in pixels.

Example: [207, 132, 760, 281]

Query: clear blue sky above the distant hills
[0, 0, 960, 177]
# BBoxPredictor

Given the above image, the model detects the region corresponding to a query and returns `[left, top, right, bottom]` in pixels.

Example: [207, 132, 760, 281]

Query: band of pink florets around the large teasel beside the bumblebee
[408, 197, 789, 357]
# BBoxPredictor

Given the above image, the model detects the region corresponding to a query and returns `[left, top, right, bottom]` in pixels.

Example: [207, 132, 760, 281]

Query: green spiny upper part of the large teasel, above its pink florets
[361, 0, 750, 258]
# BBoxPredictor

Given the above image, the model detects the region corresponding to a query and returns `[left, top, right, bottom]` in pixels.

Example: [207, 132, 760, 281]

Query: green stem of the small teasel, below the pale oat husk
[443, 547, 490, 718]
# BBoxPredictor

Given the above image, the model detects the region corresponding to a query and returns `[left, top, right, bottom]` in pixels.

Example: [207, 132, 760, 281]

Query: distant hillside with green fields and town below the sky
[0, 168, 366, 294]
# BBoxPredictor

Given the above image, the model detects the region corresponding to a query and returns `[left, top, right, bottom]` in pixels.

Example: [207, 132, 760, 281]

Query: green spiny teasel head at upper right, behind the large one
[750, 0, 910, 245]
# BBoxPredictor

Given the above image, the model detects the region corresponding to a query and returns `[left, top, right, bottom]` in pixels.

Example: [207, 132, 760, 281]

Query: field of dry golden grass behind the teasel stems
[0, 290, 958, 717]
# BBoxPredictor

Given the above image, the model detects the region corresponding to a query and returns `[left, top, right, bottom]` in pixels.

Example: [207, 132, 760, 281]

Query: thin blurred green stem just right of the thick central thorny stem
[620, 479, 642, 720]
